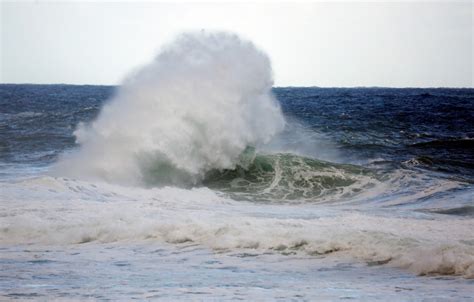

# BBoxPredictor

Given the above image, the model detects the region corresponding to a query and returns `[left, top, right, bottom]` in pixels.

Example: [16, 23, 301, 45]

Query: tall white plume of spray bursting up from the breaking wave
[55, 32, 285, 185]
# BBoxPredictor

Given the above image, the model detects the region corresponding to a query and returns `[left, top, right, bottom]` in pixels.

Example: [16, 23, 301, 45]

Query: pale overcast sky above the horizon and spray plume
[0, 0, 474, 87]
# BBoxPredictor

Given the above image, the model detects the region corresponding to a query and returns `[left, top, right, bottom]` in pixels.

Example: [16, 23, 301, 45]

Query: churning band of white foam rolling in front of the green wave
[0, 178, 474, 278]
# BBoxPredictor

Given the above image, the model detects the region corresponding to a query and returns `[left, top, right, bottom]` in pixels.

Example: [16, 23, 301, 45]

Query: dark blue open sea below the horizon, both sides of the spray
[0, 84, 474, 181]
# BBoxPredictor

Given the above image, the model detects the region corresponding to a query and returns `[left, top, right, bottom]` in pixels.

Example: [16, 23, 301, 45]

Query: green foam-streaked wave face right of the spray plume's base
[203, 151, 379, 202]
